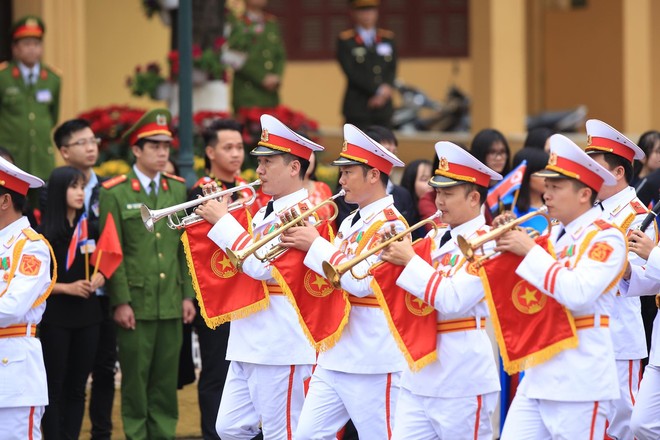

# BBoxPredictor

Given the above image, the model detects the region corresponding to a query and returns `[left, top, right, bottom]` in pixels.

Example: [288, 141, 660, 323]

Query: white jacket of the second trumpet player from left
[305, 196, 406, 374]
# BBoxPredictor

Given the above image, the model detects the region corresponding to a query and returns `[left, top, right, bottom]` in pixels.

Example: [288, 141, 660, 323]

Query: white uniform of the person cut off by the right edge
[620, 247, 660, 440]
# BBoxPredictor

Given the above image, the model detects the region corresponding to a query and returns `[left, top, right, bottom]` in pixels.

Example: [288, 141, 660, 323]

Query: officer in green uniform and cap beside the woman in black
[100, 109, 195, 439]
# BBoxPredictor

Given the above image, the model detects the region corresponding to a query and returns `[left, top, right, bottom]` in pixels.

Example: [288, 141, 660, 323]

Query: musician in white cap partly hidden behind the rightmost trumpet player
[585, 119, 656, 440]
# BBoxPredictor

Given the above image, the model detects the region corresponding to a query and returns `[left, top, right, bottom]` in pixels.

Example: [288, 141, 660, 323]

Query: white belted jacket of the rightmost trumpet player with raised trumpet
[516, 207, 626, 402]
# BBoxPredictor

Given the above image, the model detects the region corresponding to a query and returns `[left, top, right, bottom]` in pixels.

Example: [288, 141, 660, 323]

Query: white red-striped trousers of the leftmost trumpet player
[215, 361, 312, 440]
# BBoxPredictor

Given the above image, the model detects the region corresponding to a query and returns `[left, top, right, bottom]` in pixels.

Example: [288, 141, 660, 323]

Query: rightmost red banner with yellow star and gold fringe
[479, 235, 578, 374]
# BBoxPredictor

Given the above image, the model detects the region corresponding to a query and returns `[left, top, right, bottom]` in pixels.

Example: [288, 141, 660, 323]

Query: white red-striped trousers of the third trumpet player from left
[392, 388, 499, 440]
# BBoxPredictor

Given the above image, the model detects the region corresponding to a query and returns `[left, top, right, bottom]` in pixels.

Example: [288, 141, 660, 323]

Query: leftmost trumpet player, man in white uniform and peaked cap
[195, 115, 323, 439]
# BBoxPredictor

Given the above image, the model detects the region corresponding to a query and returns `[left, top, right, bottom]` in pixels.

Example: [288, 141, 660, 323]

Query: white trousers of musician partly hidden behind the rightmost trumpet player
[607, 359, 642, 440]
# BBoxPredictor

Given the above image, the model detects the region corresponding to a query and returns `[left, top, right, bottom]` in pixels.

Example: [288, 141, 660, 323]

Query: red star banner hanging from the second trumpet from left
[272, 220, 351, 351]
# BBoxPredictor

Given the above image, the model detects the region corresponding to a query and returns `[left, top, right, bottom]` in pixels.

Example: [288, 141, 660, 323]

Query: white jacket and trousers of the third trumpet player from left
[393, 215, 500, 440]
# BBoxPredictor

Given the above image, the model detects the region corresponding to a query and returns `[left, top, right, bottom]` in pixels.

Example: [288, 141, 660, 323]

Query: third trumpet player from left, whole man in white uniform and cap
[381, 142, 502, 439]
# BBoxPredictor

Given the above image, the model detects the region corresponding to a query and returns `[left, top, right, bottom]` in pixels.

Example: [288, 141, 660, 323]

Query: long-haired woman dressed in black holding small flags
[39, 166, 105, 439]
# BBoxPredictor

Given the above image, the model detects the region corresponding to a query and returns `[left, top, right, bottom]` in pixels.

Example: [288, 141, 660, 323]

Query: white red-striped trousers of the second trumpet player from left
[296, 366, 401, 440]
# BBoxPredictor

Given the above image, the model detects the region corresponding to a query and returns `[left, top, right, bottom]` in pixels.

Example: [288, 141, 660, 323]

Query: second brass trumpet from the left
[226, 189, 346, 270]
